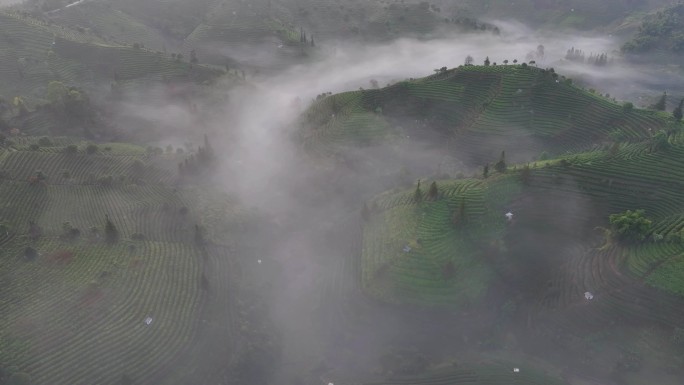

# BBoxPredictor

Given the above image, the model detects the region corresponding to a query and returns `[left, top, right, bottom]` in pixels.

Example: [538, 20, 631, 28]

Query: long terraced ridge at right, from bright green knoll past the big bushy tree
[362, 133, 684, 316]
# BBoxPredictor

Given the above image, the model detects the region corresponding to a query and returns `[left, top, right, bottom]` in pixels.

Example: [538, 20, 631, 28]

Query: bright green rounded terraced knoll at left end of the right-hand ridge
[362, 176, 521, 306]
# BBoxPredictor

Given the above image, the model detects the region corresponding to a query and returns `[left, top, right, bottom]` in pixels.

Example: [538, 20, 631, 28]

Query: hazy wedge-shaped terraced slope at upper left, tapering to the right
[0, 12, 218, 106]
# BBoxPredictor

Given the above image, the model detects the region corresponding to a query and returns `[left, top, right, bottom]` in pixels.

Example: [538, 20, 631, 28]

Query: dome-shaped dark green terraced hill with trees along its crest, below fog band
[300, 64, 667, 164]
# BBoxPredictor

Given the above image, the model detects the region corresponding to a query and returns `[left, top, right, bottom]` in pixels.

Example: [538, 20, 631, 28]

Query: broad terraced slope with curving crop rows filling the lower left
[0, 138, 247, 384]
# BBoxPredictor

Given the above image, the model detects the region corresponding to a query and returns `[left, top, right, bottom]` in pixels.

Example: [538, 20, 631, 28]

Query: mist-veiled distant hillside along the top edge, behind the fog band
[18, 0, 498, 68]
